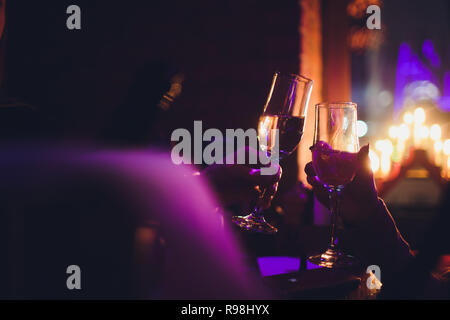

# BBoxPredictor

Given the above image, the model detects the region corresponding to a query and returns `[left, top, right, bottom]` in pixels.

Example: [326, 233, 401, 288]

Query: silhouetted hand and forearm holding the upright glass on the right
[305, 145, 411, 275]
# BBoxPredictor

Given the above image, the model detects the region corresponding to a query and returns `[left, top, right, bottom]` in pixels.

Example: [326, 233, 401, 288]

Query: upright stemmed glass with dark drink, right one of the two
[309, 102, 359, 268]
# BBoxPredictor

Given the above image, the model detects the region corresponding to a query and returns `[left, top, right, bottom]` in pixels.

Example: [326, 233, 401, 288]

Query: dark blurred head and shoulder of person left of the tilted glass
[100, 61, 179, 149]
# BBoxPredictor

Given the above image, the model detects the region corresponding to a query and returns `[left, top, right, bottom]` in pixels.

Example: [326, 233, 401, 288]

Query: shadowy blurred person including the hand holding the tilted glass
[99, 60, 281, 207]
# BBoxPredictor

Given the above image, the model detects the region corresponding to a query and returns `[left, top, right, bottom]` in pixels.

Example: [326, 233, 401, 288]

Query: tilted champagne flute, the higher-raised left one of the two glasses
[232, 72, 313, 234]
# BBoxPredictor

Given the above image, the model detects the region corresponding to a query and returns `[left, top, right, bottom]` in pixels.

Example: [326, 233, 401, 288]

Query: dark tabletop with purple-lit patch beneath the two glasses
[237, 226, 378, 299]
